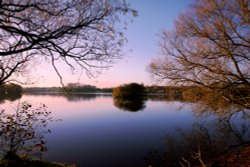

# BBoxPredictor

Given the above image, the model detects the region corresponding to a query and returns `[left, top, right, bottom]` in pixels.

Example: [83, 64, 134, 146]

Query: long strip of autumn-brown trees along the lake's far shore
[0, 83, 250, 107]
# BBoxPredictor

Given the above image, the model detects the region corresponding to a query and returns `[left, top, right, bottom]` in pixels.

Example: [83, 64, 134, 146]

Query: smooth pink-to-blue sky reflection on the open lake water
[4, 96, 195, 167]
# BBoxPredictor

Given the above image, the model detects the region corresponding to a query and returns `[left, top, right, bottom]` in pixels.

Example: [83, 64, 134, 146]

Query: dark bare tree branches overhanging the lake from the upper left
[0, 0, 137, 84]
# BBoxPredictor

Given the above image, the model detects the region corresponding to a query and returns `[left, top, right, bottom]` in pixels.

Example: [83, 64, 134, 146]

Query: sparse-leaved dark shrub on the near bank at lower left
[0, 103, 52, 159]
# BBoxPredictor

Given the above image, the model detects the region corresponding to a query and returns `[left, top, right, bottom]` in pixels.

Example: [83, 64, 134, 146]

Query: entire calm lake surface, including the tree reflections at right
[1, 94, 250, 167]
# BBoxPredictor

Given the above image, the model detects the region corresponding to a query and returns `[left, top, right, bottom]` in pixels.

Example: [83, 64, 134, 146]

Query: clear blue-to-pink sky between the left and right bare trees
[28, 0, 191, 88]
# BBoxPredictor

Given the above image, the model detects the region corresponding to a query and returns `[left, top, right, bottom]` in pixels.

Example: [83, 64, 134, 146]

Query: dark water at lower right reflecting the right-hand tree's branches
[146, 108, 250, 167]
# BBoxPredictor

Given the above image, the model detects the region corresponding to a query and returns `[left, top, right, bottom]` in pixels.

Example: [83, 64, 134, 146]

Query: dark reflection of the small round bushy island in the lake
[113, 98, 146, 112]
